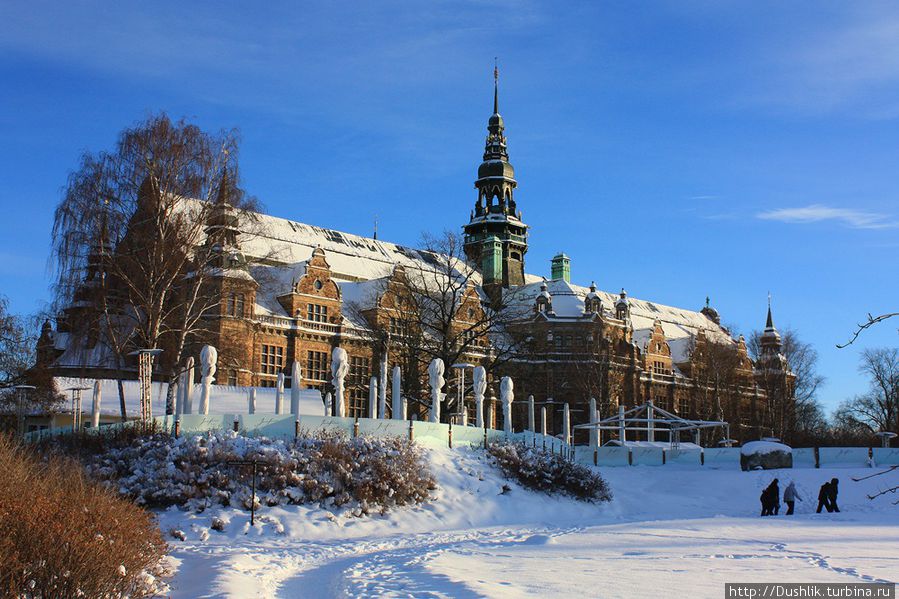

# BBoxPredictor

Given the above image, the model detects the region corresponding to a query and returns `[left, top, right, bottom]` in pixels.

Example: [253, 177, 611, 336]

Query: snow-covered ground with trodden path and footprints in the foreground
[160, 449, 899, 598]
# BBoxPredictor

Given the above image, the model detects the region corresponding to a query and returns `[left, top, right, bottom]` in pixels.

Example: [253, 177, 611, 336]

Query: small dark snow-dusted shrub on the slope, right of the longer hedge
[487, 443, 612, 501]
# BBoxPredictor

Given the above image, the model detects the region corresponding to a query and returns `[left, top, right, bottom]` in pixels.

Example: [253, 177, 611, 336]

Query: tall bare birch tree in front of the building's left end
[53, 114, 255, 417]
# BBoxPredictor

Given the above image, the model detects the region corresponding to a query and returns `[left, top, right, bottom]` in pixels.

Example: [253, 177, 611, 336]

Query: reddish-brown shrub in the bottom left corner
[0, 436, 166, 598]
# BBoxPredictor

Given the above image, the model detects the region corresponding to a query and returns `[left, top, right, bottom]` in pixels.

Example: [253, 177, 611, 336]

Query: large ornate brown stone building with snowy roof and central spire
[40, 75, 793, 439]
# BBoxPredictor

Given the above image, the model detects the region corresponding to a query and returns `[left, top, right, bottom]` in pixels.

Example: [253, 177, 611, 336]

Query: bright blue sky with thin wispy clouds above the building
[0, 0, 899, 408]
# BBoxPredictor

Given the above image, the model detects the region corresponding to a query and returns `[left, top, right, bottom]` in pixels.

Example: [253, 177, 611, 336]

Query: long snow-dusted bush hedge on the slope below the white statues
[79, 431, 435, 513]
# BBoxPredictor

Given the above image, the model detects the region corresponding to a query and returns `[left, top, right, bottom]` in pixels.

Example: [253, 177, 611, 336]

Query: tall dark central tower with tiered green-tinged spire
[464, 67, 528, 288]
